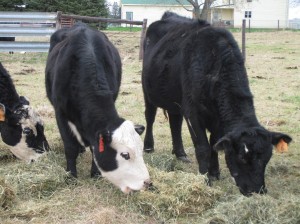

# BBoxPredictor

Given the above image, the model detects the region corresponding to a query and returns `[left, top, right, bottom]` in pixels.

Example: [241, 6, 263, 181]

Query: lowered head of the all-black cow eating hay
[214, 127, 292, 196]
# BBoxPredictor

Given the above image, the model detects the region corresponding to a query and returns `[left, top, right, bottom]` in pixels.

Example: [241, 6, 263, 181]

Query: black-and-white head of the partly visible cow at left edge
[0, 96, 49, 162]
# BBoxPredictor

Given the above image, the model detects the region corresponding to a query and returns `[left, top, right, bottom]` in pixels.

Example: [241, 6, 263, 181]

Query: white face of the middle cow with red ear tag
[94, 121, 150, 193]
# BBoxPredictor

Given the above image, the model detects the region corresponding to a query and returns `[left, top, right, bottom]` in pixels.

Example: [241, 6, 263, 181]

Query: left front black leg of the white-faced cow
[56, 113, 84, 177]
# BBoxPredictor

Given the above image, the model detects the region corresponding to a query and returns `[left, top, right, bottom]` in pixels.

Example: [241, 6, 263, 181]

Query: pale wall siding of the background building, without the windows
[121, 0, 289, 28]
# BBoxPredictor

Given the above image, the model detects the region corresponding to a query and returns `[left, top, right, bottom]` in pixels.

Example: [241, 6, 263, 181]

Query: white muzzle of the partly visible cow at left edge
[10, 135, 46, 163]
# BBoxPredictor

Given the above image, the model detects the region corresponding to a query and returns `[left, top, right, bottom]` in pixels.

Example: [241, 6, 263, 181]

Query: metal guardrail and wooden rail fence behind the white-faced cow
[0, 12, 147, 56]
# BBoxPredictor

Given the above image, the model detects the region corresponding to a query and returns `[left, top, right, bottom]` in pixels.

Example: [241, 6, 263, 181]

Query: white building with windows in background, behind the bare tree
[120, 0, 289, 28]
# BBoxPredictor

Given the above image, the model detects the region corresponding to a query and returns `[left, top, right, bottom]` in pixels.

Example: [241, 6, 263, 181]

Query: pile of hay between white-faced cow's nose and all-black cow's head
[134, 167, 221, 219]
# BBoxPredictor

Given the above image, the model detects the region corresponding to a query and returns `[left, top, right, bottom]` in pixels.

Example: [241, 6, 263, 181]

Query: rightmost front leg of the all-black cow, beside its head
[208, 133, 220, 180]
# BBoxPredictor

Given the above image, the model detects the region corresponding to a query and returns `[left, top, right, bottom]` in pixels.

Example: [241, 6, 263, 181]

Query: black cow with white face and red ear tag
[46, 23, 151, 193]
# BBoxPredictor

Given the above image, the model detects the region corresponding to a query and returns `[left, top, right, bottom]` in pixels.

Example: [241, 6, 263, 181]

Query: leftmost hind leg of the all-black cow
[144, 97, 157, 152]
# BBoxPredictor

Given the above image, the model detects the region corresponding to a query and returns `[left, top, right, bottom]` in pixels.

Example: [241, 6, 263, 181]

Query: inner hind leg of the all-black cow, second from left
[168, 113, 191, 163]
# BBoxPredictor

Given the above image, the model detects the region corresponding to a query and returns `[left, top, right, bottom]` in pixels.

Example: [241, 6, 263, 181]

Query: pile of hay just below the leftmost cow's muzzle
[2, 152, 68, 198]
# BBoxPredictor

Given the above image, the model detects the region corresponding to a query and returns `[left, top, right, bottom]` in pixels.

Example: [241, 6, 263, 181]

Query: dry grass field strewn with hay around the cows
[0, 31, 300, 224]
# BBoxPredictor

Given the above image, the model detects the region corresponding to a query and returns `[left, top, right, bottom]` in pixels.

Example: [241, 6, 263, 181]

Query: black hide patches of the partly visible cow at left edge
[0, 60, 49, 157]
